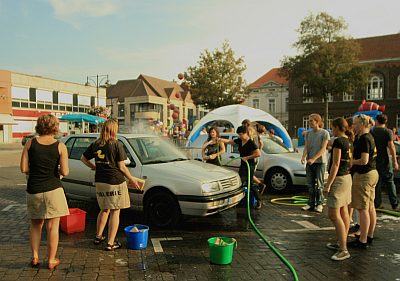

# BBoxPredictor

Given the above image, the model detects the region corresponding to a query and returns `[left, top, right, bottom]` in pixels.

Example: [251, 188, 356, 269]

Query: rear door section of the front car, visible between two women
[62, 137, 96, 198]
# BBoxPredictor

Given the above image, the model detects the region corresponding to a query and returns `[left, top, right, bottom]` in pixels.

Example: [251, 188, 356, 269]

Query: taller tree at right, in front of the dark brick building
[281, 13, 370, 121]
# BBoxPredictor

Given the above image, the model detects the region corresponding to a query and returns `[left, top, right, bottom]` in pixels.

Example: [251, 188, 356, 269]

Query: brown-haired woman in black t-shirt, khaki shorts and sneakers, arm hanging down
[324, 118, 352, 260]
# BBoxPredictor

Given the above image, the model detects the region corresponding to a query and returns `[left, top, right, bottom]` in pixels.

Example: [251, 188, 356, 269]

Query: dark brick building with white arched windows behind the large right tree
[289, 34, 400, 137]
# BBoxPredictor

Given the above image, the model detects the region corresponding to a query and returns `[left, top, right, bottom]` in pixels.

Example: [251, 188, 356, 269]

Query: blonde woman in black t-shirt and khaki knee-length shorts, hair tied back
[348, 114, 378, 249]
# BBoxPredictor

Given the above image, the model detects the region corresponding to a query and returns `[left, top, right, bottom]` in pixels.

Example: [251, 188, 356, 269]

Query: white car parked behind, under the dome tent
[187, 133, 307, 192]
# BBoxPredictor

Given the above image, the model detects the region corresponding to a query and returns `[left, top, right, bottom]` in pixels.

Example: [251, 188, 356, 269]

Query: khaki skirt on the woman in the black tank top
[26, 187, 69, 219]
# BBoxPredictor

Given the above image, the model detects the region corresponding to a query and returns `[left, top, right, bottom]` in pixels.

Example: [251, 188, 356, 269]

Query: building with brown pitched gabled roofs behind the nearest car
[107, 75, 206, 129]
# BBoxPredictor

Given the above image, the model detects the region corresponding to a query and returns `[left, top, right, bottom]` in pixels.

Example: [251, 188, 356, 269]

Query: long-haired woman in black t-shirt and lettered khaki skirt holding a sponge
[81, 119, 139, 251]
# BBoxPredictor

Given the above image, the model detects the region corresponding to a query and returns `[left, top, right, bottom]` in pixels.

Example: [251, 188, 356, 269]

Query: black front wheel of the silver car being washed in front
[145, 188, 181, 228]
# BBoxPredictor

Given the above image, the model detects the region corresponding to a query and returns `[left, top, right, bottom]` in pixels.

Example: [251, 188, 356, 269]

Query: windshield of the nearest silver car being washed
[128, 137, 188, 165]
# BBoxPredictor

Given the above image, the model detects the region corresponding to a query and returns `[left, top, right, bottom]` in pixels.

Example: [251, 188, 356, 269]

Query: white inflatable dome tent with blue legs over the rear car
[187, 104, 293, 149]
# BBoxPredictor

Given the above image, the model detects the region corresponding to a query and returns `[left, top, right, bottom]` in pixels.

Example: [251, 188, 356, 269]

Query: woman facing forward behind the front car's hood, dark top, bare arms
[201, 127, 225, 166]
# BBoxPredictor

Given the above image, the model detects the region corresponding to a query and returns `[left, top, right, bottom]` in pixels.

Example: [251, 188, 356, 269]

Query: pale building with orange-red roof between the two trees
[243, 68, 289, 128]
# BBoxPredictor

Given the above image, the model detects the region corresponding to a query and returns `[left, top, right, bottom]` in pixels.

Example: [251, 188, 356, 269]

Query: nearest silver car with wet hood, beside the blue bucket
[62, 134, 244, 227]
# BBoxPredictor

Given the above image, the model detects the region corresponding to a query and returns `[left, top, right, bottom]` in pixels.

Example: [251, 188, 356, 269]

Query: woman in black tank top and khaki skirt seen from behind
[20, 114, 69, 269]
